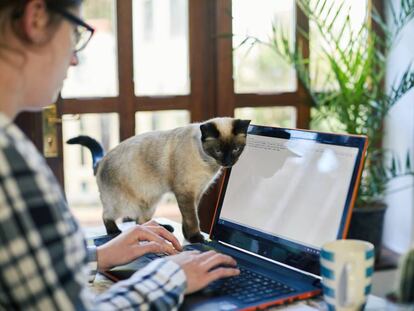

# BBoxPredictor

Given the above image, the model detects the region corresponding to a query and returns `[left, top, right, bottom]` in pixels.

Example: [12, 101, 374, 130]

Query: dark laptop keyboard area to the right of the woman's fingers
[203, 267, 295, 303]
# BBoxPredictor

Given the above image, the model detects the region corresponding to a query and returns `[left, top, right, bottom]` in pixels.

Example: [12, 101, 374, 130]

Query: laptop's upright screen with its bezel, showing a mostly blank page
[213, 126, 366, 274]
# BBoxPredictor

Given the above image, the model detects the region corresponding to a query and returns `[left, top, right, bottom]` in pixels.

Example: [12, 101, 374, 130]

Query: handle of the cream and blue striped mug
[338, 262, 357, 308]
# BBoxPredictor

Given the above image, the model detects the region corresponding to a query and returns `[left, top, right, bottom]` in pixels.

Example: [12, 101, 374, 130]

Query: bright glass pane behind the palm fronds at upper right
[309, 0, 367, 91]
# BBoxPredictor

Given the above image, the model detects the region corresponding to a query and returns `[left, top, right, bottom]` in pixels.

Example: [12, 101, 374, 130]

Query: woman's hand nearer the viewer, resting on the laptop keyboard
[168, 251, 240, 294]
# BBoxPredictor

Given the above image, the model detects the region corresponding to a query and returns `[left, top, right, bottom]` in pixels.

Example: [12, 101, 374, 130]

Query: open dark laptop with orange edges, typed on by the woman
[96, 125, 367, 310]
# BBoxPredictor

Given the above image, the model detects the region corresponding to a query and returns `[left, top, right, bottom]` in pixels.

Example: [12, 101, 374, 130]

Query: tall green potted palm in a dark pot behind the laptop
[242, 0, 414, 258]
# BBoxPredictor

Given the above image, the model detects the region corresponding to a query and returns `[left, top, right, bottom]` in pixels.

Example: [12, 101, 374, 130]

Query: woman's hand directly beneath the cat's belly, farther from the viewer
[97, 221, 182, 271]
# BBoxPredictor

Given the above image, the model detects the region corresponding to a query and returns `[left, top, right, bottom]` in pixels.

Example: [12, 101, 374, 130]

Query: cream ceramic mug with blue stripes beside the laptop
[320, 240, 374, 311]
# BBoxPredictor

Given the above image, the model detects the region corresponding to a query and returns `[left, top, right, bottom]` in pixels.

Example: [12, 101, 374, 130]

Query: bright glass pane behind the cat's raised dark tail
[62, 113, 119, 226]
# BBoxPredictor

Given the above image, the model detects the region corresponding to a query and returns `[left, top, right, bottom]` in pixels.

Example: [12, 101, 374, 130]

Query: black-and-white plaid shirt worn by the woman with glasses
[0, 114, 186, 311]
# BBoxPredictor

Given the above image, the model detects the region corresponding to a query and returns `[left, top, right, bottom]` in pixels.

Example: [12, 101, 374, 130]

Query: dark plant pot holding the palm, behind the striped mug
[348, 202, 387, 261]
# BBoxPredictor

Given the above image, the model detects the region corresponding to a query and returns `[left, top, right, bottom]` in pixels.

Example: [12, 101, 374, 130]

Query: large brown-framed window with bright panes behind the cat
[58, 0, 316, 230]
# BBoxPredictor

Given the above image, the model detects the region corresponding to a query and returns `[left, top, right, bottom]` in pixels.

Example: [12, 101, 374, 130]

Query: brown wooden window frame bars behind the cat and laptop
[58, 0, 310, 231]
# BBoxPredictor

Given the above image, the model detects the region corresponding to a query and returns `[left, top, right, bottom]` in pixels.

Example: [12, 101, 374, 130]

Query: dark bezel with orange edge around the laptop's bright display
[210, 125, 367, 275]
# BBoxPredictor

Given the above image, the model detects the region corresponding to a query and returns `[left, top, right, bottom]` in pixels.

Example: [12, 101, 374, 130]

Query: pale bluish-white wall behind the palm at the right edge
[384, 0, 414, 253]
